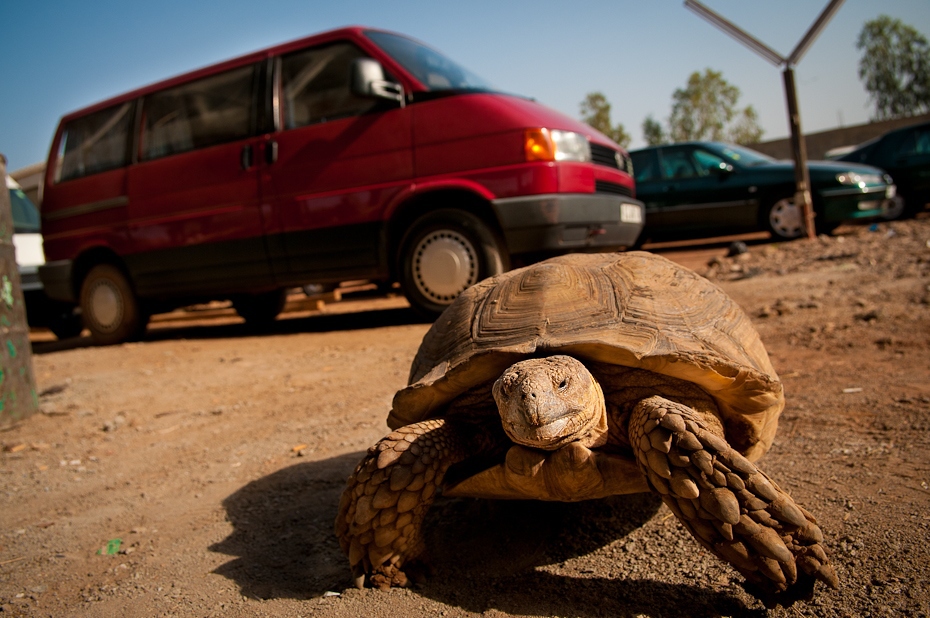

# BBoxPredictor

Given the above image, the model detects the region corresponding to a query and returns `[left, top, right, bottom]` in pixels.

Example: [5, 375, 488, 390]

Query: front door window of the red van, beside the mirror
[281, 43, 377, 129]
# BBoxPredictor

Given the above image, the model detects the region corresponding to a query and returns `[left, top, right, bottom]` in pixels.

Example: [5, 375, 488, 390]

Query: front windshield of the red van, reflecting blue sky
[365, 30, 495, 91]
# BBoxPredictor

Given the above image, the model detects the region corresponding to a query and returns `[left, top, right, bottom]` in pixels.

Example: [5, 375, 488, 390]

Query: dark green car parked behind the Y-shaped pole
[630, 142, 895, 243]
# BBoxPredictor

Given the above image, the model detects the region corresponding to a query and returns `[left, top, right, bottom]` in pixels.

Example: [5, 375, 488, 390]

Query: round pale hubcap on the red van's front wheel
[413, 230, 478, 304]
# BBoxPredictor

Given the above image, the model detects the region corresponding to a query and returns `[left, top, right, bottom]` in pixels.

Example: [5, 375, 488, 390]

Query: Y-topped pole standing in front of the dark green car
[685, 0, 843, 238]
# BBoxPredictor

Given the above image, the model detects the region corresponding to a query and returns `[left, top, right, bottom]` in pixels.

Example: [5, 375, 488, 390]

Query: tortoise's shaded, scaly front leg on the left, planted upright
[335, 419, 482, 588]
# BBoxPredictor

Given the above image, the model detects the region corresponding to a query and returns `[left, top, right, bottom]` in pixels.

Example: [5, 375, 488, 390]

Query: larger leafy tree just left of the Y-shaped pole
[668, 69, 763, 144]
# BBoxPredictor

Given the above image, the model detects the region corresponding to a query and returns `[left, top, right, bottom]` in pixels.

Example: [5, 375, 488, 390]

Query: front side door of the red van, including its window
[267, 41, 413, 281]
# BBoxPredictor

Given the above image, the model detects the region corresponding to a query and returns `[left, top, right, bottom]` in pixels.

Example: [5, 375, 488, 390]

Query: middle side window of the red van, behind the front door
[139, 65, 255, 160]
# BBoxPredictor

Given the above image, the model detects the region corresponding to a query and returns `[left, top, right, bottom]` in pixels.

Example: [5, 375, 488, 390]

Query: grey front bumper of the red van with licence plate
[492, 193, 646, 255]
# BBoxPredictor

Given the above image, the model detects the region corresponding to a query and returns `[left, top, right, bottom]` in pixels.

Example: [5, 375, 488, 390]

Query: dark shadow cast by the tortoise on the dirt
[209, 451, 760, 616]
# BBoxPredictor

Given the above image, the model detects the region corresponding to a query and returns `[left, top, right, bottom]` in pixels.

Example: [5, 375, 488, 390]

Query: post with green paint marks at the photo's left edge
[0, 155, 39, 427]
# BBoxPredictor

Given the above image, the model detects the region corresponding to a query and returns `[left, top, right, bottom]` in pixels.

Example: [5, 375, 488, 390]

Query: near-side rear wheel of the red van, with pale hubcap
[81, 264, 148, 345]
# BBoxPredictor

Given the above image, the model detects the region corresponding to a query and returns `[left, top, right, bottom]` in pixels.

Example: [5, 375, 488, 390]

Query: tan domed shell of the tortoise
[388, 251, 784, 460]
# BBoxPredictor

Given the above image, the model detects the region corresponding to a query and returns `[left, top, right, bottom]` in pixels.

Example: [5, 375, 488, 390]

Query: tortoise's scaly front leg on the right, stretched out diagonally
[629, 397, 838, 604]
